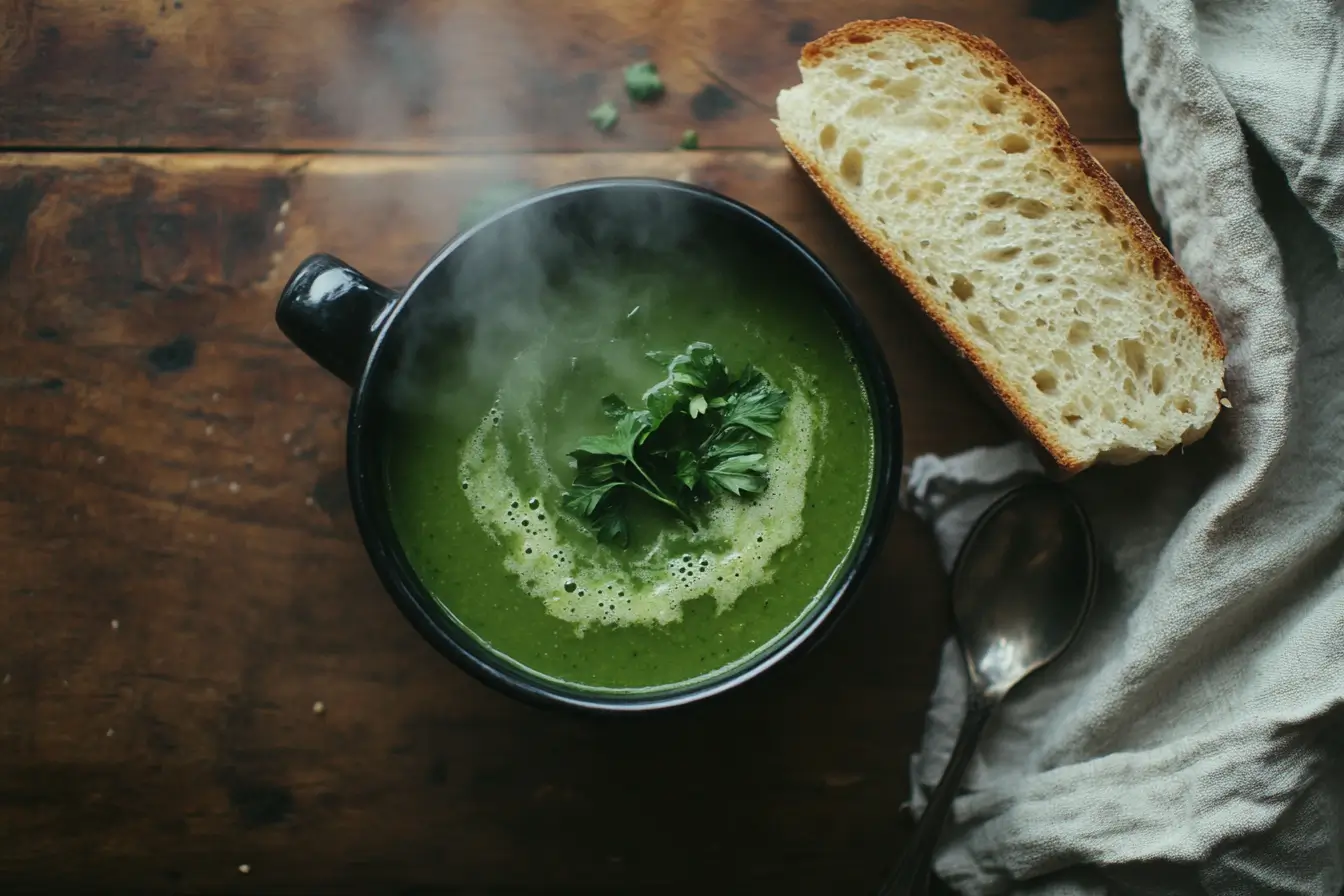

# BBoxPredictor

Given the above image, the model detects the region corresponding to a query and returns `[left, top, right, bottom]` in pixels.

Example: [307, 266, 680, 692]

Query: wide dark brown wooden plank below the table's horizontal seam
[0, 149, 1142, 893]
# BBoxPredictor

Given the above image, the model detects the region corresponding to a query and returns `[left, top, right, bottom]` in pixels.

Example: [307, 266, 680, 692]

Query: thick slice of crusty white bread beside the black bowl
[775, 19, 1227, 473]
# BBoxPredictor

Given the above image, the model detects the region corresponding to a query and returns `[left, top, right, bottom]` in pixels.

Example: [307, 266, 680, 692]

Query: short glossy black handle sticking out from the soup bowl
[276, 255, 398, 386]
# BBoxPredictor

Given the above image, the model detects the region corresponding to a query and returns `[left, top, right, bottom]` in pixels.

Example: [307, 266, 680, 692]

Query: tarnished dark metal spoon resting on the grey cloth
[878, 480, 1097, 896]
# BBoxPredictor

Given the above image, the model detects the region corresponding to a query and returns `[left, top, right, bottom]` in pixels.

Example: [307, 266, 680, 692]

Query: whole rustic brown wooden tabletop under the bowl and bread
[0, 0, 1150, 893]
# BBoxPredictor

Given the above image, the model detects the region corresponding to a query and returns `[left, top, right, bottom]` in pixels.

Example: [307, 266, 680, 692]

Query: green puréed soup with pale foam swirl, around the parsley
[384, 236, 874, 690]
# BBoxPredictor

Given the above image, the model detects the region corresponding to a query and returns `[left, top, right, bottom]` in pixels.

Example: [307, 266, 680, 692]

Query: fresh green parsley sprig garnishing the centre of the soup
[562, 343, 789, 545]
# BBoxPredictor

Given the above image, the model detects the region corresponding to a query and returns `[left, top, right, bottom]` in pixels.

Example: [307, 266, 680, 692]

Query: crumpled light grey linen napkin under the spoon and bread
[907, 0, 1344, 896]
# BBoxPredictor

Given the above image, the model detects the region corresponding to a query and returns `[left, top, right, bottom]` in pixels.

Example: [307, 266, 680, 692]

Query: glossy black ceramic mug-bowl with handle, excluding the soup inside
[276, 179, 900, 712]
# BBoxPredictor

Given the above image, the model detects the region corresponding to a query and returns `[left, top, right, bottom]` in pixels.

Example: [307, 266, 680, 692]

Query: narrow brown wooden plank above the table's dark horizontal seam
[0, 0, 1137, 152]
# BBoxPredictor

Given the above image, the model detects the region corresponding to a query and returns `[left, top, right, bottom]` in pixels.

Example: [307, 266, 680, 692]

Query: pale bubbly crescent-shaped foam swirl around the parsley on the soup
[458, 368, 827, 631]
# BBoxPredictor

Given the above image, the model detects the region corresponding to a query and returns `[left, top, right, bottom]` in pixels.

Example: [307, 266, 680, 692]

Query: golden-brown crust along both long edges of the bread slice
[784, 19, 1227, 476]
